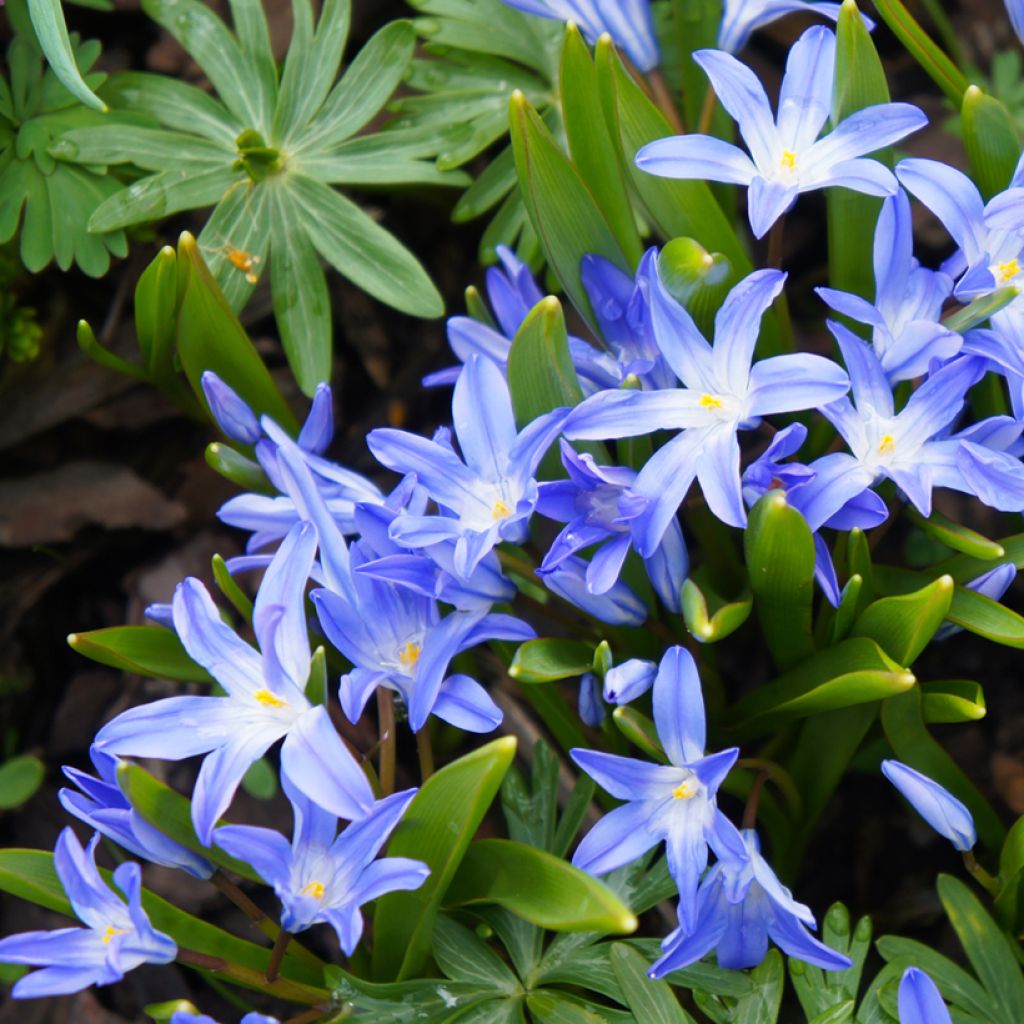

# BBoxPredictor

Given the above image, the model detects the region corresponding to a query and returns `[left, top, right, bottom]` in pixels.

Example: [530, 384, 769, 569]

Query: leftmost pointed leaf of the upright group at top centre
[509, 91, 628, 324]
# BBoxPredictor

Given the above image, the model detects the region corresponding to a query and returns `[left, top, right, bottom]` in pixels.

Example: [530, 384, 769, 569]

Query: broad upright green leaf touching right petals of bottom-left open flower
[374, 736, 516, 980]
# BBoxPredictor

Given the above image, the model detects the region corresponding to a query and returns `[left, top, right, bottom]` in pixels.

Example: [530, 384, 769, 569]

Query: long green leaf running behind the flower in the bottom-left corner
[0, 850, 329, 1006]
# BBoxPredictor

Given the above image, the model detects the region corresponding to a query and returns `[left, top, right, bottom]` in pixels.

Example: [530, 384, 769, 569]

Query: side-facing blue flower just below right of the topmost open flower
[816, 189, 964, 382]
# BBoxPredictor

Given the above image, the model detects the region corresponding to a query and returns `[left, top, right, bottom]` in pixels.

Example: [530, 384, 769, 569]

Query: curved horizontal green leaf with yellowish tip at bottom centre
[444, 839, 637, 935]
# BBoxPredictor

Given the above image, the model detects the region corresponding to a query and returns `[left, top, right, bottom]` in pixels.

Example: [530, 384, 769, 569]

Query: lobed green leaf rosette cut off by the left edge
[0, 27, 128, 278]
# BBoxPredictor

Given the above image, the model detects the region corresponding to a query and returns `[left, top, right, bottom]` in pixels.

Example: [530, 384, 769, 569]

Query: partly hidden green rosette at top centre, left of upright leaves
[391, 0, 564, 266]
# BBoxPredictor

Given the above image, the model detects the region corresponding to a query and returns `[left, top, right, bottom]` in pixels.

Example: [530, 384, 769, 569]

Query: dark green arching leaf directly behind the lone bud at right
[882, 686, 1006, 850]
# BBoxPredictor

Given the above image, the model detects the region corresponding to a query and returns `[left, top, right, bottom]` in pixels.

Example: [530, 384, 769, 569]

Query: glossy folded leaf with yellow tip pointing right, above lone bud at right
[727, 637, 914, 737]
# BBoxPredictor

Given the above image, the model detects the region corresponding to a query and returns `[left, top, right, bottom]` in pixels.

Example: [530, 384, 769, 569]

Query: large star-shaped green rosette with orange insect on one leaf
[54, 0, 466, 394]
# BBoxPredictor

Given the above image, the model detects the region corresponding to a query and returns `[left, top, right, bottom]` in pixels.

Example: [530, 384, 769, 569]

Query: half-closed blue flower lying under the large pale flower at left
[57, 743, 214, 879]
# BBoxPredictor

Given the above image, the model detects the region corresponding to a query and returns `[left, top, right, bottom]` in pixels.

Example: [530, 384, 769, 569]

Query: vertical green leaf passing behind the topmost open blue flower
[827, 0, 892, 300]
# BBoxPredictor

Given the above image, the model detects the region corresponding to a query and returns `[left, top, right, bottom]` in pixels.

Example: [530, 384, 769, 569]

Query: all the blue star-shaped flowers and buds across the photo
[0, 0, 1024, 1024]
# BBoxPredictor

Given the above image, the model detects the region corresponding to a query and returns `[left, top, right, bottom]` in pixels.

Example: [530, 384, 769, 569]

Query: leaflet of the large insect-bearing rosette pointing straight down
[270, 194, 332, 395]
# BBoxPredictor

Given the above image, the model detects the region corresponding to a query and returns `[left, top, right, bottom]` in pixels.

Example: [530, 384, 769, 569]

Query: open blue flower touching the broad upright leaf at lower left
[215, 772, 430, 956]
